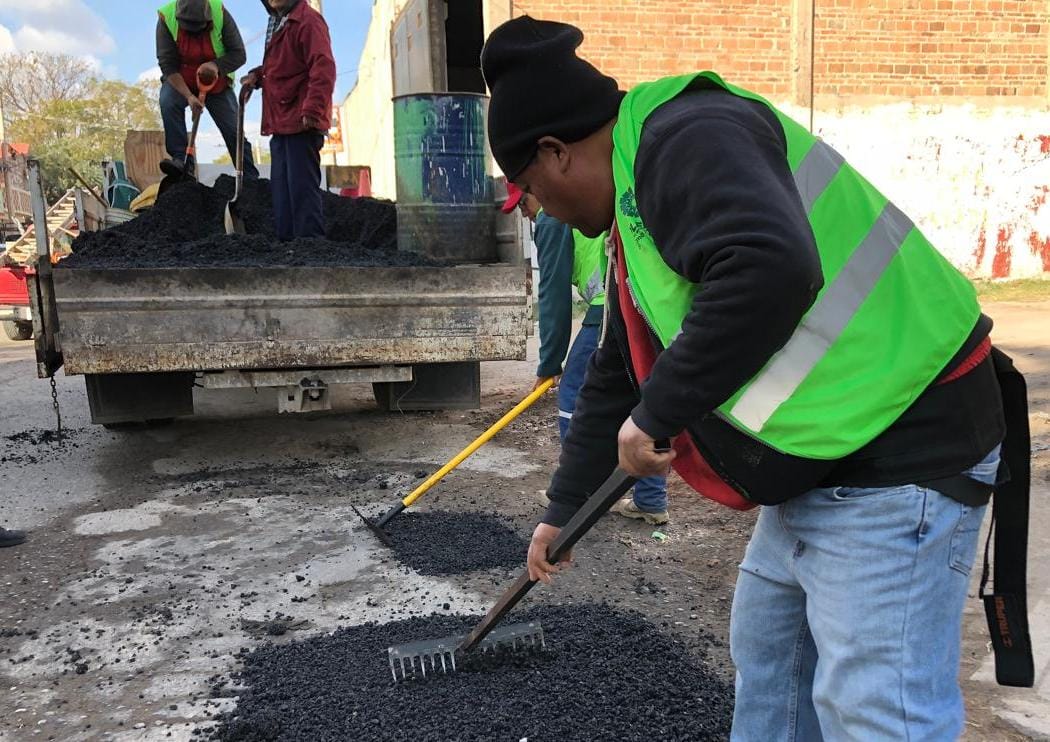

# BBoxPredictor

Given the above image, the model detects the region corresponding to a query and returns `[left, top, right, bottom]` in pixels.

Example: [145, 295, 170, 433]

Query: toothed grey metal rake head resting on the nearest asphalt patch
[386, 621, 547, 682]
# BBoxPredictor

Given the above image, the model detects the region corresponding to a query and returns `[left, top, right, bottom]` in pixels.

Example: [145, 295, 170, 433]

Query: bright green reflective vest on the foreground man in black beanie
[612, 71, 981, 460]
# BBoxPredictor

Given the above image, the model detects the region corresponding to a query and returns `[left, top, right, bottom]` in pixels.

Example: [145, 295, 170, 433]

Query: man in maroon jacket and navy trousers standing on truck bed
[242, 0, 336, 240]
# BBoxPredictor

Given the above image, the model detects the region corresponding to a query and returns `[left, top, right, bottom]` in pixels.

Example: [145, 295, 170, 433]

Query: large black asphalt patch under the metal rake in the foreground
[202, 605, 733, 742]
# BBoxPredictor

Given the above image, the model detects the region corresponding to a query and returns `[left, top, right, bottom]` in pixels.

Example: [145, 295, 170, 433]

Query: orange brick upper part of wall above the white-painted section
[513, 0, 1050, 103]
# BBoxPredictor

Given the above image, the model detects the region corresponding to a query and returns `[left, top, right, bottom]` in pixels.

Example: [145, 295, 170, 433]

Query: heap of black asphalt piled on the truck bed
[60, 175, 443, 269]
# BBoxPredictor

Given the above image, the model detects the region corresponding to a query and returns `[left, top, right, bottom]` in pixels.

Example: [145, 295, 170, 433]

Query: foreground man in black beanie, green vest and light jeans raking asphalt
[482, 17, 1027, 742]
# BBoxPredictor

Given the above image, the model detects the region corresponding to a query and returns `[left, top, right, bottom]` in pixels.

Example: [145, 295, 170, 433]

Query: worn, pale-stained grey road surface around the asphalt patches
[0, 302, 1050, 741]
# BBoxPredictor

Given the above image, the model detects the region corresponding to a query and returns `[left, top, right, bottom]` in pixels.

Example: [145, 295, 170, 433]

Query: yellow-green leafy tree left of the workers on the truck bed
[11, 80, 161, 202]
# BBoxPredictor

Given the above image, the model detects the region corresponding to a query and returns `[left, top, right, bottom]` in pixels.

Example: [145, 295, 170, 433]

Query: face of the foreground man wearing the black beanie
[515, 136, 615, 237]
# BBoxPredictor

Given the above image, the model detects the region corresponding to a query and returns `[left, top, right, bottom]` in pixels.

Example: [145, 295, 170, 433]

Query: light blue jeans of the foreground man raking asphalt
[730, 447, 999, 742]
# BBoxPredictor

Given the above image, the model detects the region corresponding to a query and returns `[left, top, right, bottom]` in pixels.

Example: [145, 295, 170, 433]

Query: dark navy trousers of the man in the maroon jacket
[270, 131, 324, 241]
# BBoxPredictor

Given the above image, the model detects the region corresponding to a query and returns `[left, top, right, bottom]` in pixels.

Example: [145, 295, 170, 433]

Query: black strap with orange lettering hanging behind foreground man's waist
[979, 347, 1035, 687]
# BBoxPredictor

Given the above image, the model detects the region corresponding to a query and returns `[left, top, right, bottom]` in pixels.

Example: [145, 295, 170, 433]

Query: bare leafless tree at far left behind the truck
[0, 51, 95, 124]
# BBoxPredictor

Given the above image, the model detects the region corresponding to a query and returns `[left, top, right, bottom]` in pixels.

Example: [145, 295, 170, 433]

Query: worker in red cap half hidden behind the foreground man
[503, 183, 670, 526]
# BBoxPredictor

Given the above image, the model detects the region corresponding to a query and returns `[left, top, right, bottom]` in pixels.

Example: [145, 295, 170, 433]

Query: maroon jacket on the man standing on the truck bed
[255, 0, 335, 135]
